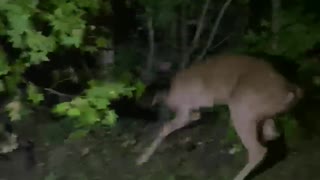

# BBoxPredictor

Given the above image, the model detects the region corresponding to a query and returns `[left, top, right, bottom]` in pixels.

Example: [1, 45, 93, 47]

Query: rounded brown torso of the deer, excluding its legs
[169, 55, 296, 112]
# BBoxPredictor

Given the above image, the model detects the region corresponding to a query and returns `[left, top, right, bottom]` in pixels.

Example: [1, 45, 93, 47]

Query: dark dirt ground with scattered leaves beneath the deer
[0, 102, 320, 180]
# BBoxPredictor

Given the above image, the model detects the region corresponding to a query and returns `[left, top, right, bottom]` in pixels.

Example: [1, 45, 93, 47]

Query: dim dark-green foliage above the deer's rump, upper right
[243, 8, 320, 60]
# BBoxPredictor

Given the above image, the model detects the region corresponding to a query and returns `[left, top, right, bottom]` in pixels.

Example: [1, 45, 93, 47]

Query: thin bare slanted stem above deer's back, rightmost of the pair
[196, 0, 232, 61]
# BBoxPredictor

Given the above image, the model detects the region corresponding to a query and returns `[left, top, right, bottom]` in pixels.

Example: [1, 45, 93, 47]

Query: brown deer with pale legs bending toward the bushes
[136, 54, 303, 180]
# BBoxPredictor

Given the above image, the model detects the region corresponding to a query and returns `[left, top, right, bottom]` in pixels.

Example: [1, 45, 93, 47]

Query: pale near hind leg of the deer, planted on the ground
[230, 104, 267, 180]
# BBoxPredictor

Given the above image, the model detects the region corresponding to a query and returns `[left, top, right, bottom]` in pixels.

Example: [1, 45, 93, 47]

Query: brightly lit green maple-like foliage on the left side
[0, 0, 143, 138]
